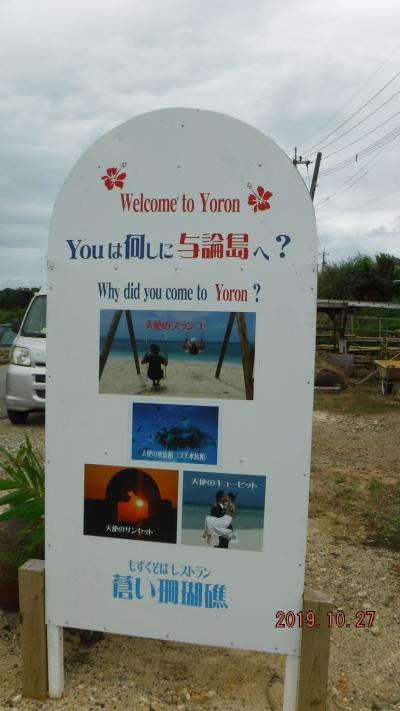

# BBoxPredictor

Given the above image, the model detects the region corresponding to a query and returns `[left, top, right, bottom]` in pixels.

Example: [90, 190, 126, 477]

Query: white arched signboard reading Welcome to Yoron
[46, 109, 317, 655]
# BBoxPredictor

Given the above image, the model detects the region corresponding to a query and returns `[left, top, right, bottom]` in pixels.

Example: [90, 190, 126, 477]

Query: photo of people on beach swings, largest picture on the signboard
[99, 309, 256, 400]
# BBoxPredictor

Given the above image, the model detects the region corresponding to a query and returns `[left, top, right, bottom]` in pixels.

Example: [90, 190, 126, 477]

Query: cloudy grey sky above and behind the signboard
[0, 0, 400, 288]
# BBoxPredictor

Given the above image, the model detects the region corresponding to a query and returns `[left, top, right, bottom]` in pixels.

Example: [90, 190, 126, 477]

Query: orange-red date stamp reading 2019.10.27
[275, 610, 376, 629]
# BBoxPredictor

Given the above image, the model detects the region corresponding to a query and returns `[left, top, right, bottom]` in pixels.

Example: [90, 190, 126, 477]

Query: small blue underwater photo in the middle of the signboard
[131, 402, 219, 465]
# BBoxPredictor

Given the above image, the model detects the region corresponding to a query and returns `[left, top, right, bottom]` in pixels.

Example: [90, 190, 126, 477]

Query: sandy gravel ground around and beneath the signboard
[0, 411, 400, 711]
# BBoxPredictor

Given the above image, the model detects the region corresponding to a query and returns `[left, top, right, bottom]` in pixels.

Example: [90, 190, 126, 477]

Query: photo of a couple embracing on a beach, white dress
[181, 471, 266, 551]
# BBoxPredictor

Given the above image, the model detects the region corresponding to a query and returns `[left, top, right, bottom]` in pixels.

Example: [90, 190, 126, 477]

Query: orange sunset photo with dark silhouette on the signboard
[84, 464, 178, 543]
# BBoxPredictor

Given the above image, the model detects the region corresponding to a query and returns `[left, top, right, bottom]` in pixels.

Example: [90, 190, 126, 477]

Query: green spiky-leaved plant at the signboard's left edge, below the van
[0, 437, 45, 567]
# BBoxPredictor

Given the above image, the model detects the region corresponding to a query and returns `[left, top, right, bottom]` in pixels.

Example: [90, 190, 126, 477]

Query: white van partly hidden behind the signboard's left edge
[6, 289, 47, 425]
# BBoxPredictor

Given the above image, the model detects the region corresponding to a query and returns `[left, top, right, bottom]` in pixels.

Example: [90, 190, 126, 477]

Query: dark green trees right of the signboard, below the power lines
[318, 253, 400, 302]
